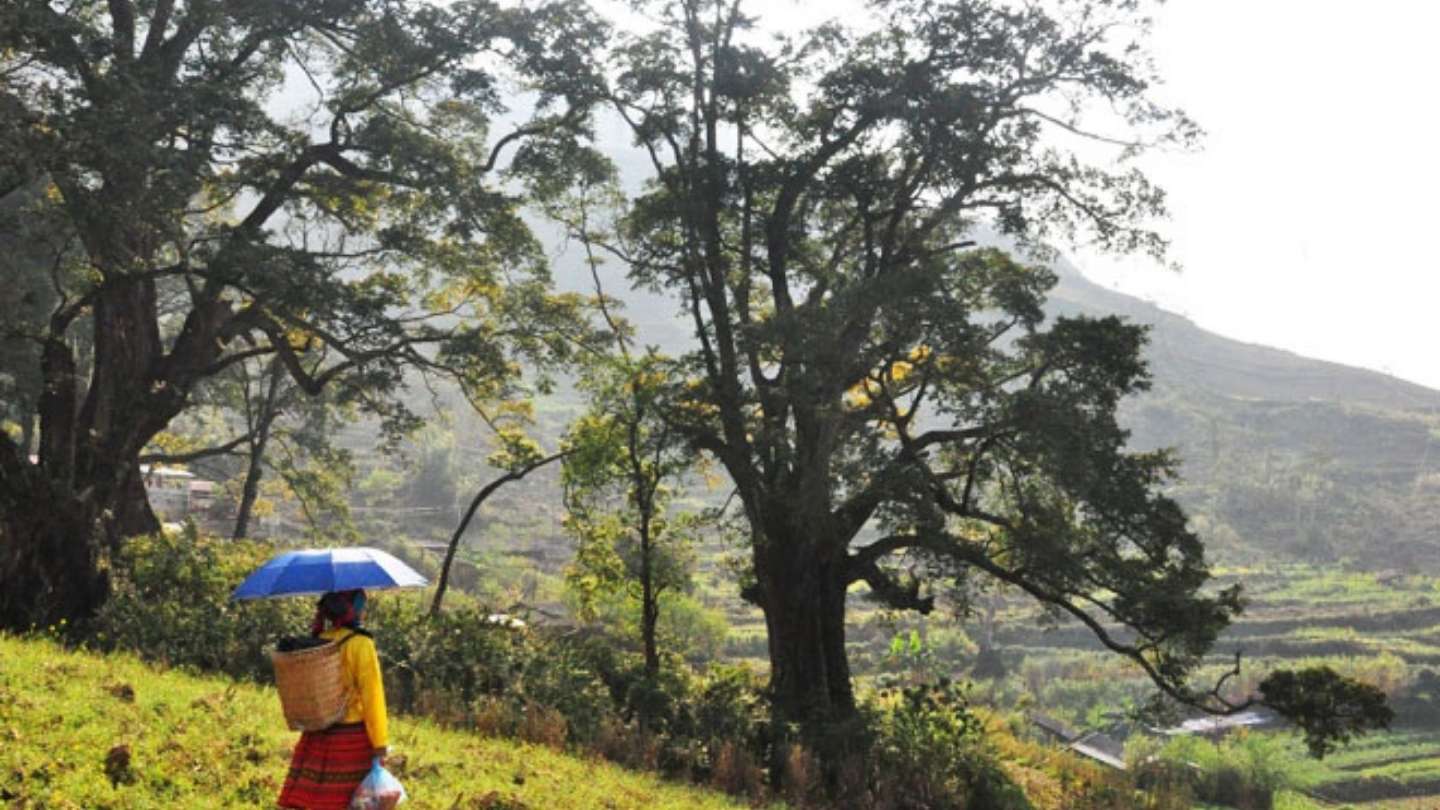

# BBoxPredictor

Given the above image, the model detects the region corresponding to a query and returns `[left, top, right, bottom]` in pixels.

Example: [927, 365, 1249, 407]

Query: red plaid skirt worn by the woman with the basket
[279, 724, 373, 810]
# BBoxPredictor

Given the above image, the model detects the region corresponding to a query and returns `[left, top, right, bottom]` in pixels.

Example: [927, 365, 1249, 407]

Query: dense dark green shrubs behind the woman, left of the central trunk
[78, 529, 765, 760]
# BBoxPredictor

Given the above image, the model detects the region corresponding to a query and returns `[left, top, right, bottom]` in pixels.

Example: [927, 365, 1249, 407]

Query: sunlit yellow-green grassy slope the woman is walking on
[0, 636, 766, 810]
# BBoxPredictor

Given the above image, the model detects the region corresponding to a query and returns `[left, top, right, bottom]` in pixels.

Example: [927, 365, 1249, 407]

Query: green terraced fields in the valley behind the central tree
[696, 565, 1440, 810]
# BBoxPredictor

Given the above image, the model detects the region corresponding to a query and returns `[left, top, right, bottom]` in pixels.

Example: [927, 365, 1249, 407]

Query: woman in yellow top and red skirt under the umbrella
[279, 591, 389, 810]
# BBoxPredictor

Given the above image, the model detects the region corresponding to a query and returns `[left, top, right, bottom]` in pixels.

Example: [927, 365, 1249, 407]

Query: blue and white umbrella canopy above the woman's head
[230, 548, 429, 600]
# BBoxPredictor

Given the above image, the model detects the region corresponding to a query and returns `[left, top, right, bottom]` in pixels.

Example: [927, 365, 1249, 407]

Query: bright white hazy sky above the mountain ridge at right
[1076, 0, 1440, 388]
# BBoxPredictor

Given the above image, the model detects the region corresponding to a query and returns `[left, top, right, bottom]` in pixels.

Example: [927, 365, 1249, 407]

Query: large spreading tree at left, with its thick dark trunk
[0, 0, 603, 624]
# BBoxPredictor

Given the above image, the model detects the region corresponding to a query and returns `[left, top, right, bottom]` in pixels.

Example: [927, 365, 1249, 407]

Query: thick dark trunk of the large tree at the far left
[0, 280, 200, 630]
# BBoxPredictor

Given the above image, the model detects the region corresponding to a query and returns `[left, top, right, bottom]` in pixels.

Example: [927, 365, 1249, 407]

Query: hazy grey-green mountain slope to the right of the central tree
[1048, 255, 1440, 571]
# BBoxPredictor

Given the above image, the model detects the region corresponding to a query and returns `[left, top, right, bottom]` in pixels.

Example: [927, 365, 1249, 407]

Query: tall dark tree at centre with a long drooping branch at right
[595, 0, 1388, 760]
